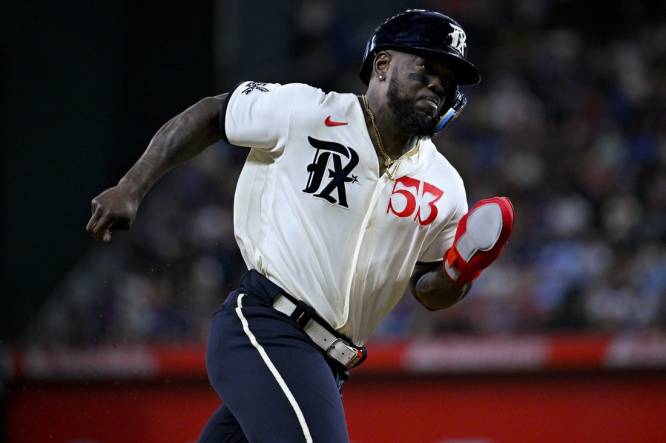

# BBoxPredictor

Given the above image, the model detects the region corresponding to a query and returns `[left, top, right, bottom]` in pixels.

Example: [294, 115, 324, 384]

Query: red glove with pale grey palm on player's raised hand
[444, 197, 513, 283]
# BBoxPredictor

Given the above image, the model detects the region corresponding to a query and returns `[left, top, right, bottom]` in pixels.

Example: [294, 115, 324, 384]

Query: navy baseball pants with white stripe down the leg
[199, 271, 349, 443]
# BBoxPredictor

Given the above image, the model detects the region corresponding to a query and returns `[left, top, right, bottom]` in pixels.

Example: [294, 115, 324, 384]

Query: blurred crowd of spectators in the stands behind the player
[6, 0, 666, 345]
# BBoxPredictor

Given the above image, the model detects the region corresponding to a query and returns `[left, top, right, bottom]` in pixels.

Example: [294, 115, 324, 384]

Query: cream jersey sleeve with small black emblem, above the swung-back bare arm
[220, 81, 298, 150]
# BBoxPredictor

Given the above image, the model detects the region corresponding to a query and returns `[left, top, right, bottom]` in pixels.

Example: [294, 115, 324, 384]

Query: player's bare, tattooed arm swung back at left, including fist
[86, 94, 227, 242]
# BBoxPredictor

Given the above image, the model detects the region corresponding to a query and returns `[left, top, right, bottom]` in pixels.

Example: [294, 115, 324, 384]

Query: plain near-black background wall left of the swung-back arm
[0, 1, 215, 339]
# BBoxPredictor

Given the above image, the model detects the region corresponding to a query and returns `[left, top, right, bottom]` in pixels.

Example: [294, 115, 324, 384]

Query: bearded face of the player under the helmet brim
[387, 52, 454, 137]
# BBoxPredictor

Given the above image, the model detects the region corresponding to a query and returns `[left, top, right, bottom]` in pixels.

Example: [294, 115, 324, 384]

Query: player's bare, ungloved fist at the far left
[86, 185, 140, 242]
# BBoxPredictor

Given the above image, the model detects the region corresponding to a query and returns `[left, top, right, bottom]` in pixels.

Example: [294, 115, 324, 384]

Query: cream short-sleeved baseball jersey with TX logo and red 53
[221, 82, 467, 346]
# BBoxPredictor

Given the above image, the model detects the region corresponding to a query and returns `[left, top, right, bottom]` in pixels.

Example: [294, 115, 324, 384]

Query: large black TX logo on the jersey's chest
[303, 137, 358, 208]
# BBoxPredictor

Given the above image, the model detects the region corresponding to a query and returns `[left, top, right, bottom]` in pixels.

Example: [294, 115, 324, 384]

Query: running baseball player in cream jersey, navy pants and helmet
[87, 10, 513, 443]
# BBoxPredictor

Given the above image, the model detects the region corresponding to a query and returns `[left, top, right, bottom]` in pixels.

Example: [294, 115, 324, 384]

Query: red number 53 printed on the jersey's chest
[386, 176, 444, 226]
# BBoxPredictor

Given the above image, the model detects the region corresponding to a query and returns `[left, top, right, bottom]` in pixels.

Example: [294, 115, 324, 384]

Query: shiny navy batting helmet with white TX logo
[361, 9, 481, 85]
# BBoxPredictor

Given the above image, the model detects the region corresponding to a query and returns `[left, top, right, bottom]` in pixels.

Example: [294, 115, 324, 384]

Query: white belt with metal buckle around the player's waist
[273, 294, 363, 368]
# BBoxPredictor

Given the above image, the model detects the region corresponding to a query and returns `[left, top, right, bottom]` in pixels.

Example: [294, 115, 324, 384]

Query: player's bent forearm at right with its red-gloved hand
[410, 197, 514, 311]
